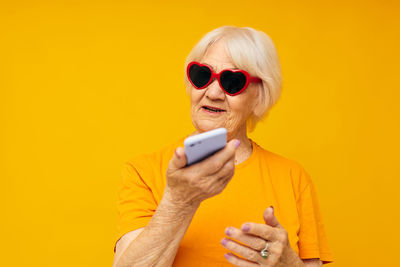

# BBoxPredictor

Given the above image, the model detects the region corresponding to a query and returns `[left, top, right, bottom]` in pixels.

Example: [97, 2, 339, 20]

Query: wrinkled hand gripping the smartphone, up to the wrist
[165, 139, 240, 206]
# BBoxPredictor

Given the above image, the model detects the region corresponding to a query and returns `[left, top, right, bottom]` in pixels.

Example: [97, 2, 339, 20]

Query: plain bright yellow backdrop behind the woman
[0, 0, 400, 267]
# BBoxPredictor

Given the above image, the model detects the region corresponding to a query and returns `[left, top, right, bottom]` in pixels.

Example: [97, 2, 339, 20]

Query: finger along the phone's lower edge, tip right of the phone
[199, 139, 240, 174]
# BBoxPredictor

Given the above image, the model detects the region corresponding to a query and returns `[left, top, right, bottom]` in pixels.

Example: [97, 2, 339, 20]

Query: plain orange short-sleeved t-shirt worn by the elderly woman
[117, 139, 333, 267]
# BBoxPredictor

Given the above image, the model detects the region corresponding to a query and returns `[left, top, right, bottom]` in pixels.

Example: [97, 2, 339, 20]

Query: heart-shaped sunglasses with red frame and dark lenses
[186, 61, 261, 96]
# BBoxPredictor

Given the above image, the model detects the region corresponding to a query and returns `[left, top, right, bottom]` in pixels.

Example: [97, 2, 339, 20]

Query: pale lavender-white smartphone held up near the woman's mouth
[184, 128, 226, 165]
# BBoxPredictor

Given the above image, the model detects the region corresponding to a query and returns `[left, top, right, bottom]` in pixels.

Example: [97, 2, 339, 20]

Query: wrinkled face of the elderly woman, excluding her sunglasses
[190, 40, 260, 138]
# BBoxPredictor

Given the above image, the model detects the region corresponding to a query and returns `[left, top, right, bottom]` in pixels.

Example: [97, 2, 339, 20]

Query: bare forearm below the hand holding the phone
[116, 193, 198, 267]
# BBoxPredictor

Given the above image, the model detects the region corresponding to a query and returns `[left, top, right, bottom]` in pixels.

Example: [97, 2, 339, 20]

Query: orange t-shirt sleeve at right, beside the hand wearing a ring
[297, 172, 333, 263]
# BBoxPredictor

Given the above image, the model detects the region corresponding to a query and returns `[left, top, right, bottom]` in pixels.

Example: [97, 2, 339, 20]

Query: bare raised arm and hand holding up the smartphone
[114, 140, 239, 267]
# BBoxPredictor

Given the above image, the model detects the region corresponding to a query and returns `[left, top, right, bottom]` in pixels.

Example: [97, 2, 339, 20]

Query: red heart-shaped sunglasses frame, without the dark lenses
[186, 61, 262, 96]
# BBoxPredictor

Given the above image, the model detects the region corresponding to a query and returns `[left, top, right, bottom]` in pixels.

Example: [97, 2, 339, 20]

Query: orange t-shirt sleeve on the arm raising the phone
[116, 162, 157, 247]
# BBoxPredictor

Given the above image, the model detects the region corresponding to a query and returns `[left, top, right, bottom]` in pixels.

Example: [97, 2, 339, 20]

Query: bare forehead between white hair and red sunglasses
[201, 40, 235, 69]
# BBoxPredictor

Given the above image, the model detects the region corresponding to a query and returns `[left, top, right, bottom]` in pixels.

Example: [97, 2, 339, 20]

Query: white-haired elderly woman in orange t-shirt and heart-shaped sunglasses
[114, 26, 332, 267]
